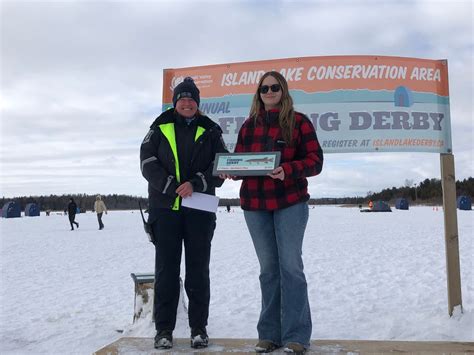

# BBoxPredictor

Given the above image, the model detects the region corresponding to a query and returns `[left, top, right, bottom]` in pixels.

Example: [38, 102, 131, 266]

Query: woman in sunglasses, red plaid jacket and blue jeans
[235, 71, 323, 354]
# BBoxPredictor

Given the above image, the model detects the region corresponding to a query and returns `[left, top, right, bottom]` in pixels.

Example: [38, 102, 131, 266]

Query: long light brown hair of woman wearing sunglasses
[249, 71, 295, 145]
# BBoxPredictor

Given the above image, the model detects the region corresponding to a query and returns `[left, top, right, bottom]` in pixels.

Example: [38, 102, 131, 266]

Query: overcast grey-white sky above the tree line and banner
[0, 0, 474, 198]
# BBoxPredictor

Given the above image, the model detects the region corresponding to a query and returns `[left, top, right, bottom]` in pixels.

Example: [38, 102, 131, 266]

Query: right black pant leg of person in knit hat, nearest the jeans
[183, 208, 216, 329]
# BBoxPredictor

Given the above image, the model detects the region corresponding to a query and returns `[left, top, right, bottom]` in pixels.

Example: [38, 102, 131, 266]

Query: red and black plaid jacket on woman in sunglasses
[235, 110, 323, 210]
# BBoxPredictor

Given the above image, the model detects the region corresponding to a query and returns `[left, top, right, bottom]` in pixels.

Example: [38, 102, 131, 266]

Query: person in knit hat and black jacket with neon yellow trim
[140, 77, 227, 349]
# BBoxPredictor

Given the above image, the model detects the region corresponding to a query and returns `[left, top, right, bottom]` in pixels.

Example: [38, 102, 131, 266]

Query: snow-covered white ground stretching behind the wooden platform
[0, 206, 474, 354]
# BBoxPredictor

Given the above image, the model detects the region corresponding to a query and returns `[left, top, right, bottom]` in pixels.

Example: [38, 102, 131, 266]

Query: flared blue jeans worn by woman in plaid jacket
[244, 202, 312, 348]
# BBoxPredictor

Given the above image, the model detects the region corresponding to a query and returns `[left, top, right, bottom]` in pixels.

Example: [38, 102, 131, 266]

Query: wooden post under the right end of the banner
[440, 153, 462, 316]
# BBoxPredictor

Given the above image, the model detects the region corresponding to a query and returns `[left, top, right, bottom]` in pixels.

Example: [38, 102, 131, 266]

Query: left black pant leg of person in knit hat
[152, 209, 183, 331]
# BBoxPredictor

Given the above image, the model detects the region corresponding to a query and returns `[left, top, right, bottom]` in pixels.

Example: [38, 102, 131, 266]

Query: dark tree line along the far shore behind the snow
[0, 177, 474, 212]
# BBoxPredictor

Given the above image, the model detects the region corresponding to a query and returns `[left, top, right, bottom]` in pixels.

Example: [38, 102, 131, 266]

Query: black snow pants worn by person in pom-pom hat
[149, 207, 216, 331]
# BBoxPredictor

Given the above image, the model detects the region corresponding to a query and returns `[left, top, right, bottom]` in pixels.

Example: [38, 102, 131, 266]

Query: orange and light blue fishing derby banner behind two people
[163, 56, 452, 153]
